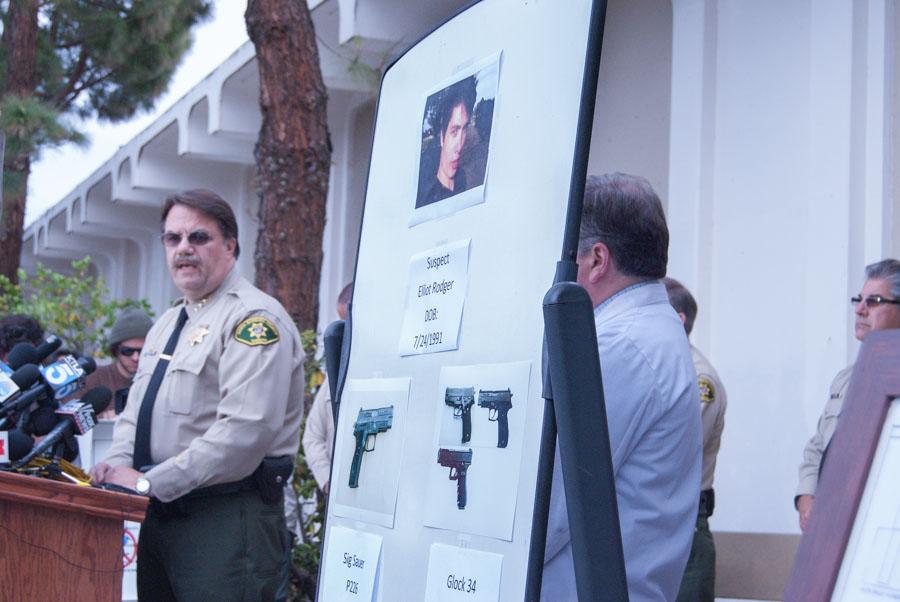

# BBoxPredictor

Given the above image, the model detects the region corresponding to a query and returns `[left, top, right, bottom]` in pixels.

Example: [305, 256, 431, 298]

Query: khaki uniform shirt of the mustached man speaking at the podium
[106, 270, 304, 502]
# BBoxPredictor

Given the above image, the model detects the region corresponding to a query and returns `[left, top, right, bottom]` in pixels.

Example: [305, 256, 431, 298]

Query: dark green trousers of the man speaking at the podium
[137, 491, 290, 602]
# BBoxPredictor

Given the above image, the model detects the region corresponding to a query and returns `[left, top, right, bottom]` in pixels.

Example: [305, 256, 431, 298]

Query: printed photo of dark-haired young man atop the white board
[410, 55, 500, 225]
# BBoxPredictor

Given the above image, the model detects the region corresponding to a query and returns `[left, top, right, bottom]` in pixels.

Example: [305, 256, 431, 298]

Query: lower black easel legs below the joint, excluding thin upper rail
[525, 274, 628, 600]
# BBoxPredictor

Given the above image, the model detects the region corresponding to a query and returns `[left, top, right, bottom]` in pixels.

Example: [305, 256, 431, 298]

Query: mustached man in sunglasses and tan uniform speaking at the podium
[94, 190, 304, 601]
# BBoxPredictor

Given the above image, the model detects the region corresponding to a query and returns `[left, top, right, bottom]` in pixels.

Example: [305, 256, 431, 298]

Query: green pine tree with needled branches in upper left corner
[0, 0, 210, 282]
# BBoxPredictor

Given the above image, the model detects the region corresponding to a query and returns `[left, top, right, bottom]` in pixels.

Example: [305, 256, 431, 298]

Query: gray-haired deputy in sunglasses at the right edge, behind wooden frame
[794, 259, 900, 531]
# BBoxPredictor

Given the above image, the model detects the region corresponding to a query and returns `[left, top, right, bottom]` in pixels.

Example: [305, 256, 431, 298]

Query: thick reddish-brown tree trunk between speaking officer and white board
[244, 0, 331, 330]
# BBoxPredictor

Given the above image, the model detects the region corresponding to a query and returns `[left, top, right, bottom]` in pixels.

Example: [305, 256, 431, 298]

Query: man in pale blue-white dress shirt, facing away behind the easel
[541, 174, 701, 602]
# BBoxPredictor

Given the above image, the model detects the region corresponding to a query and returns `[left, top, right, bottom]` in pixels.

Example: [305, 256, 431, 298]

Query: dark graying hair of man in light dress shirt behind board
[578, 173, 669, 279]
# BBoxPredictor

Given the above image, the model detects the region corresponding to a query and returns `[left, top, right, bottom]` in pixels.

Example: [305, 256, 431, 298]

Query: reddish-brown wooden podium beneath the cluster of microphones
[0, 472, 147, 602]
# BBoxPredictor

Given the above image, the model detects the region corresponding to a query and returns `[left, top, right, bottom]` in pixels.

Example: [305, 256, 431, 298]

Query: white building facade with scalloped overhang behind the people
[22, 0, 900, 598]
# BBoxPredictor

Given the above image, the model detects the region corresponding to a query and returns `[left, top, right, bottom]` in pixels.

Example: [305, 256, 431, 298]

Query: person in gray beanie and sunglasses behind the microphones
[85, 307, 153, 419]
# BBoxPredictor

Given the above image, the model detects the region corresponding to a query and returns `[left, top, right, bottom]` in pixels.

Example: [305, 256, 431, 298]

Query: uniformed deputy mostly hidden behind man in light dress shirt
[663, 278, 728, 602]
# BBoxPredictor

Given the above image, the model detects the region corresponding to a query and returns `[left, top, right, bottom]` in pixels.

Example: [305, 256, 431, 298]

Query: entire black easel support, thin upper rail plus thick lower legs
[525, 0, 628, 602]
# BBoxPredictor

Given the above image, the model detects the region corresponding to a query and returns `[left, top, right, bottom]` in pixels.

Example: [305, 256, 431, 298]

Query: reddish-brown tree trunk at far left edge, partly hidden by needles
[0, 0, 39, 282]
